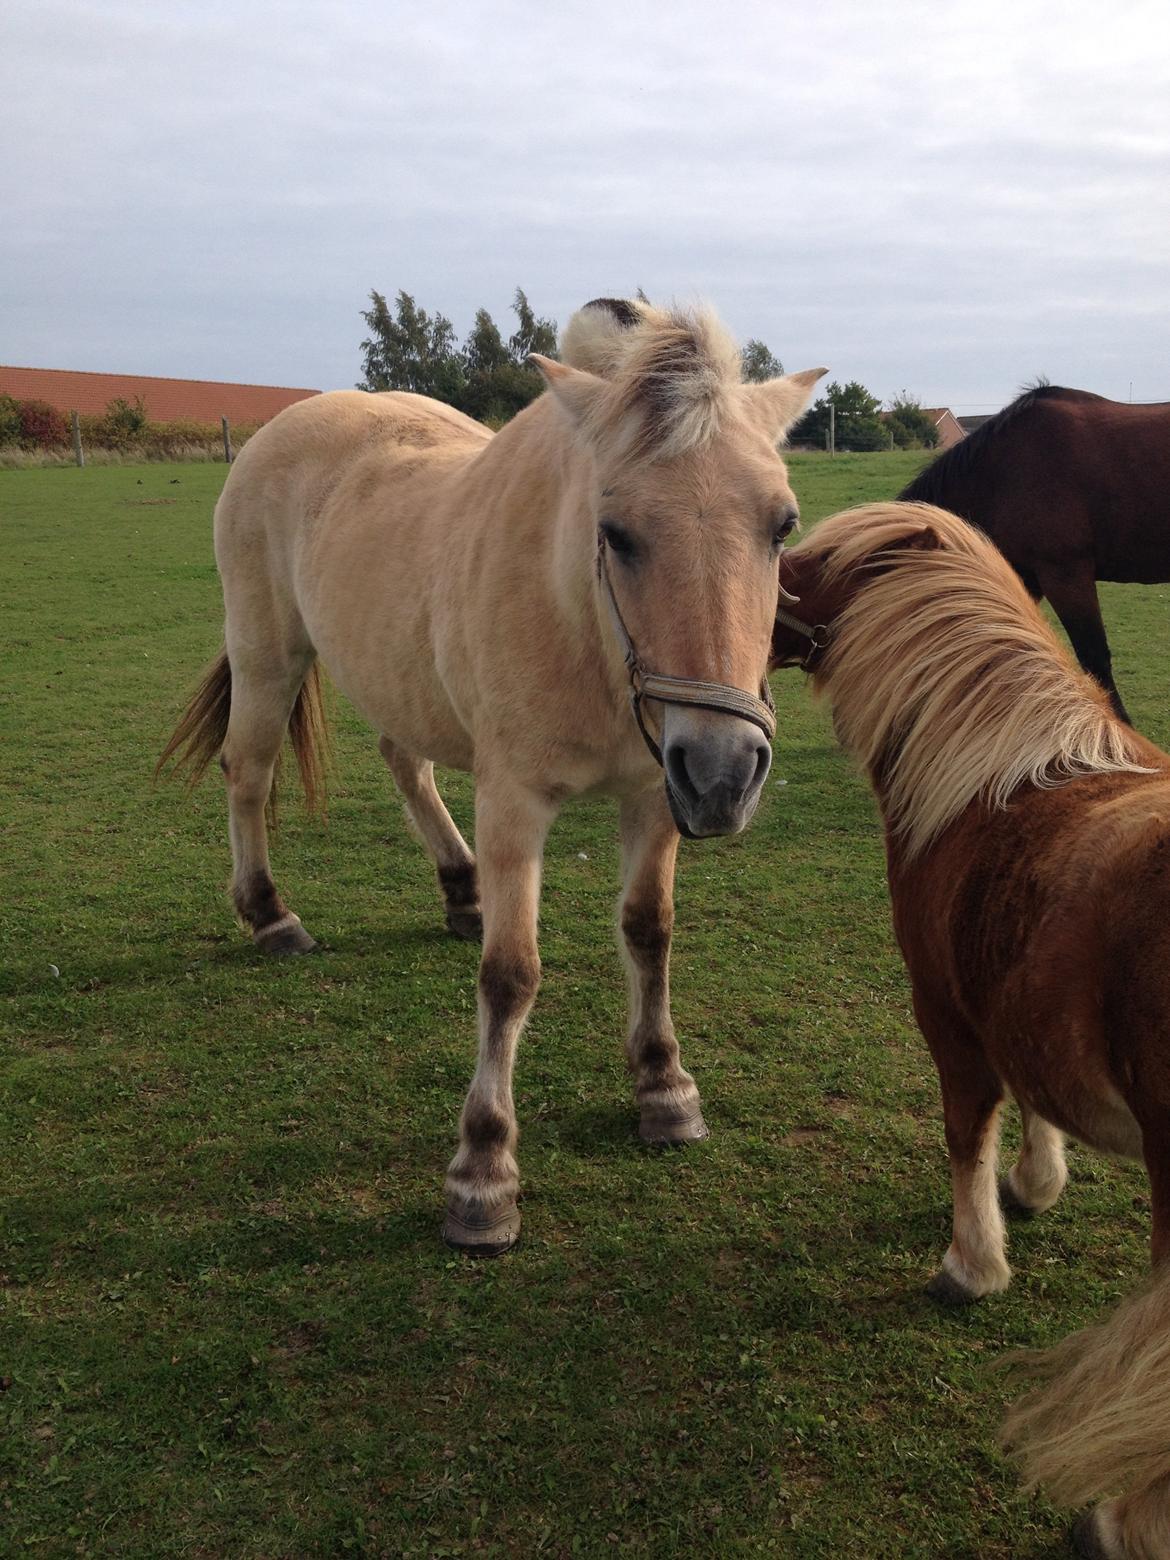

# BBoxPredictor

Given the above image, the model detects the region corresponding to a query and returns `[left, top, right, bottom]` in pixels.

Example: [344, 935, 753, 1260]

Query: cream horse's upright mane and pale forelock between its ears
[560, 298, 743, 460]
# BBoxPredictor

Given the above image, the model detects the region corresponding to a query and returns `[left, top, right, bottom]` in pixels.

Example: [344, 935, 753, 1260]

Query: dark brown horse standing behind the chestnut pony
[900, 385, 1170, 721]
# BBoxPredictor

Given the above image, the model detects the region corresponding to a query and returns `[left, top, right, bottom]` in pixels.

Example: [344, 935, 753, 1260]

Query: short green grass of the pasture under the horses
[0, 456, 1170, 1560]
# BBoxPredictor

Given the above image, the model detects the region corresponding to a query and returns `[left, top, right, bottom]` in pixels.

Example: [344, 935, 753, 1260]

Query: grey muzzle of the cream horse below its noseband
[661, 705, 772, 839]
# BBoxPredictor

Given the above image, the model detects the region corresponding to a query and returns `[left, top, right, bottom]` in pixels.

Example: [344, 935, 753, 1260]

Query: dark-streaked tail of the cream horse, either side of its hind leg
[154, 649, 331, 822]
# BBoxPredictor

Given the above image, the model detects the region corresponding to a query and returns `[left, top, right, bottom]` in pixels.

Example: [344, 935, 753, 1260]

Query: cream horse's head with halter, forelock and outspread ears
[537, 300, 825, 838]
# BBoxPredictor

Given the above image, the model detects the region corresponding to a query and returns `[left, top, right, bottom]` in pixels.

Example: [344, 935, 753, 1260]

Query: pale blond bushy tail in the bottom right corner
[1000, 1264, 1170, 1522]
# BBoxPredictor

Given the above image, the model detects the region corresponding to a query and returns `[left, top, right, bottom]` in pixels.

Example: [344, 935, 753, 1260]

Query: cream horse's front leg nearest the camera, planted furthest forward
[443, 782, 554, 1256]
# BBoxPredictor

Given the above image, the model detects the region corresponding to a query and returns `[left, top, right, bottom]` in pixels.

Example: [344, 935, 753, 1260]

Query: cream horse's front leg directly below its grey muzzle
[619, 786, 707, 1143]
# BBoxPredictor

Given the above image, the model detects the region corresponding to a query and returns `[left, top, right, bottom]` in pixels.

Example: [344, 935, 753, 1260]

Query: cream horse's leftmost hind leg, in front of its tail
[220, 652, 317, 955]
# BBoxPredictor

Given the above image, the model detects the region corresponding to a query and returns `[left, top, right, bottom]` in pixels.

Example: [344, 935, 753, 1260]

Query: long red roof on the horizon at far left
[0, 365, 320, 424]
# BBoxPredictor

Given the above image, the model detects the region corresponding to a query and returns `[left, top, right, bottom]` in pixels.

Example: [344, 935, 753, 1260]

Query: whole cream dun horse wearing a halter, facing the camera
[164, 300, 825, 1254]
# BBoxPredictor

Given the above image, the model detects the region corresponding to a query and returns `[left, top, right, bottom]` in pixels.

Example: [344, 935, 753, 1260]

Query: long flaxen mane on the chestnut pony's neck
[792, 504, 1148, 856]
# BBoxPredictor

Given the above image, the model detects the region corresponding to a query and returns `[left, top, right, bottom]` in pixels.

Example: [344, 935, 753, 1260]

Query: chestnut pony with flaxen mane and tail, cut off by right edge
[774, 504, 1170, 1560]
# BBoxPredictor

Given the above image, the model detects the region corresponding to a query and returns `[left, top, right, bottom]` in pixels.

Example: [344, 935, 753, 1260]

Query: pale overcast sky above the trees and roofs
[0, 0, 1170, 412]
